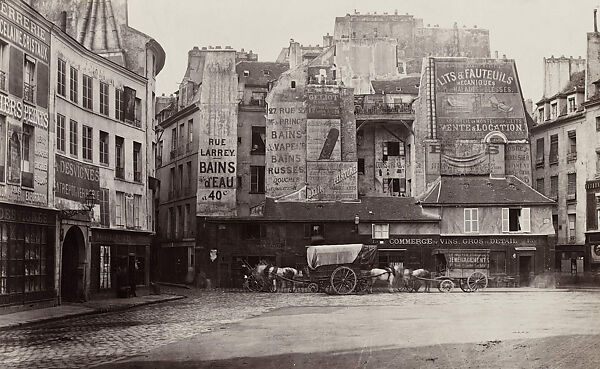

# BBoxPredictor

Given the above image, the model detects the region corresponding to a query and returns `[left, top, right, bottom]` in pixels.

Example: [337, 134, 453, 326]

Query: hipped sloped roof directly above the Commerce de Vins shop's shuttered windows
[423, 175, 554, 205]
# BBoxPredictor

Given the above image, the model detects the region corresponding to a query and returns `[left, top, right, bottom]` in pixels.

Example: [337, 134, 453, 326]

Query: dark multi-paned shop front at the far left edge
[0, 203, 56, 306]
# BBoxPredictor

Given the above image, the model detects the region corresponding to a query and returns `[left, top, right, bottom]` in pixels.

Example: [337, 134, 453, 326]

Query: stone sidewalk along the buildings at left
[0, 294, 185, 331]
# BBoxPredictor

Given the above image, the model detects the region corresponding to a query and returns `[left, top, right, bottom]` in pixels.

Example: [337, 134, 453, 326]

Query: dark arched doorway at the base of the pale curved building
[60, 226, 85, 301]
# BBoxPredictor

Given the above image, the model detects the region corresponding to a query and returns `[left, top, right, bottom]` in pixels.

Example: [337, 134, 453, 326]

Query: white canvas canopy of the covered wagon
[306, 243, 377, 269]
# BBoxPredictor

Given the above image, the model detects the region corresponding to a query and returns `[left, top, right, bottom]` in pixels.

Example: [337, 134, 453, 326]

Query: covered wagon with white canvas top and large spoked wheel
[306, 244, 377, 295]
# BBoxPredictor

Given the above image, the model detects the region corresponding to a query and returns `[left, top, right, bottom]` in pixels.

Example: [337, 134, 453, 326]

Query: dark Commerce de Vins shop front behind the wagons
[379, 235, 553, 286]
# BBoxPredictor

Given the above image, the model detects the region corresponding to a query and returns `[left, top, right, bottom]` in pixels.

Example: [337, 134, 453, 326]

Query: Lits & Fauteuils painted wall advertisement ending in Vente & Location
[435, 59, 527, 140]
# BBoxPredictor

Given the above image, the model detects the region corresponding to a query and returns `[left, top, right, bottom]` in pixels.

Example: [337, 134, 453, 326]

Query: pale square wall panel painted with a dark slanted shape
[306, 119, 341, 161]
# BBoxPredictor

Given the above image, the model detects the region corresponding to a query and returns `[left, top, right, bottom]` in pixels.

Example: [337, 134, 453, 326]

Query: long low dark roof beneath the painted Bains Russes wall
[264, 197, 439, 222]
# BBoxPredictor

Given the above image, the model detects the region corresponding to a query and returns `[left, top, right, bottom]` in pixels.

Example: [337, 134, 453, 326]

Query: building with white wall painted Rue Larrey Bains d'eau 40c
[157, 47, 288, 282]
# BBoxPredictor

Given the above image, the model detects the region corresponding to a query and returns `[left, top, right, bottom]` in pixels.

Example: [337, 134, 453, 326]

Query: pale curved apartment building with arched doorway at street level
[29, 0, 165, 300]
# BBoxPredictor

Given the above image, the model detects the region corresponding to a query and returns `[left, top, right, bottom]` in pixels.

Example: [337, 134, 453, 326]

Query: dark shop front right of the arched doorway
[90, 228, 152, 294]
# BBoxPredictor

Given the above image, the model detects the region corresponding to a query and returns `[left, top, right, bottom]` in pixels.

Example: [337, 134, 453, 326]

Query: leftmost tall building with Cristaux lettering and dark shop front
[0, 0, 58, 309]
